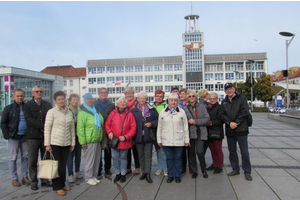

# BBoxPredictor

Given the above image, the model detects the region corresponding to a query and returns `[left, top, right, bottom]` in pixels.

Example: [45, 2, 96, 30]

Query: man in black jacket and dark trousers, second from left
[24, 86, 52, 190]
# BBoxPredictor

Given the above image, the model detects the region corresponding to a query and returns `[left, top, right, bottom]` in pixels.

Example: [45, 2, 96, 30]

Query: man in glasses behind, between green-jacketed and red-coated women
[94, 87, 115, 176]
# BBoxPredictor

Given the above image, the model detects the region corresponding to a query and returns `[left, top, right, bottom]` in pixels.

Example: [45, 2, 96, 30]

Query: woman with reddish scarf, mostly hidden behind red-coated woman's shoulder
[124, 87, 140, 175]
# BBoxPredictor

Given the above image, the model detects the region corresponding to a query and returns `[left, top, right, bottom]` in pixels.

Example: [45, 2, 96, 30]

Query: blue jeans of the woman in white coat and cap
[163, 146, 183, 177]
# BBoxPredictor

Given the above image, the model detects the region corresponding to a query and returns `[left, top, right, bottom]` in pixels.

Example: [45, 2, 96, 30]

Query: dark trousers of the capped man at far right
[227, 135, 251, 174]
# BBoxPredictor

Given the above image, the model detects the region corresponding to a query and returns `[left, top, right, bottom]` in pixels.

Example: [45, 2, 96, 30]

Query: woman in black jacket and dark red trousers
[207, 92, 224, 174]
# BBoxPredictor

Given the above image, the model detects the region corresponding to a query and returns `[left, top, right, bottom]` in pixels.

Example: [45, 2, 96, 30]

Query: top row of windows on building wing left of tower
[88, 64, 182, 74]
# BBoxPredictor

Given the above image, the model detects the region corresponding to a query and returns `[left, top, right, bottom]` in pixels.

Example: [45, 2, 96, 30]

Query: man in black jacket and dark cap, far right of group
[221, 83, 252, 181]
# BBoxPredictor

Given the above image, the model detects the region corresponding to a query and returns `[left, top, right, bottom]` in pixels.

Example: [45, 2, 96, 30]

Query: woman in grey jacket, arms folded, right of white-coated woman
[183, 91, 210, 179]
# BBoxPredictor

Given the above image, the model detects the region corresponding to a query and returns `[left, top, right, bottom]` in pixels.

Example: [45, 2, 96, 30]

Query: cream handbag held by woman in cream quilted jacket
[38, 151, 59, 179]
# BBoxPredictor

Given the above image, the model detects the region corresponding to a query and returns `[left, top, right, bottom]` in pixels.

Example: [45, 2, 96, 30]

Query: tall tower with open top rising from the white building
[182, 14, 204, 92]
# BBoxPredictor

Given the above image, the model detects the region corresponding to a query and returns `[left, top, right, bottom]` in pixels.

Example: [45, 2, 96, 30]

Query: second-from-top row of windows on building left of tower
[89, 74, 183, 84]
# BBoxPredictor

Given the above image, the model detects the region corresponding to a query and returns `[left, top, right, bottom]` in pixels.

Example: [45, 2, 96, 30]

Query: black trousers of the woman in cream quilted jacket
[51, 145, 70, 191]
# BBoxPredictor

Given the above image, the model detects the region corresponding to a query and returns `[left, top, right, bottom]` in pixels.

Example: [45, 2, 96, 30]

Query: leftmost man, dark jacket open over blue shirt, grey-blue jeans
[1, 89, 30, 187]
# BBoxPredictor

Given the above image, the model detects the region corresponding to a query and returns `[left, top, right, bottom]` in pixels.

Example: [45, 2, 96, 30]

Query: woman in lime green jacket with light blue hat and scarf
[77, 93, 103, 185]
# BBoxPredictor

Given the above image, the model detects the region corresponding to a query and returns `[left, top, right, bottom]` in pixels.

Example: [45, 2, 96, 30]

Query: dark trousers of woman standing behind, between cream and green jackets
[67, 137, 81, 176]
